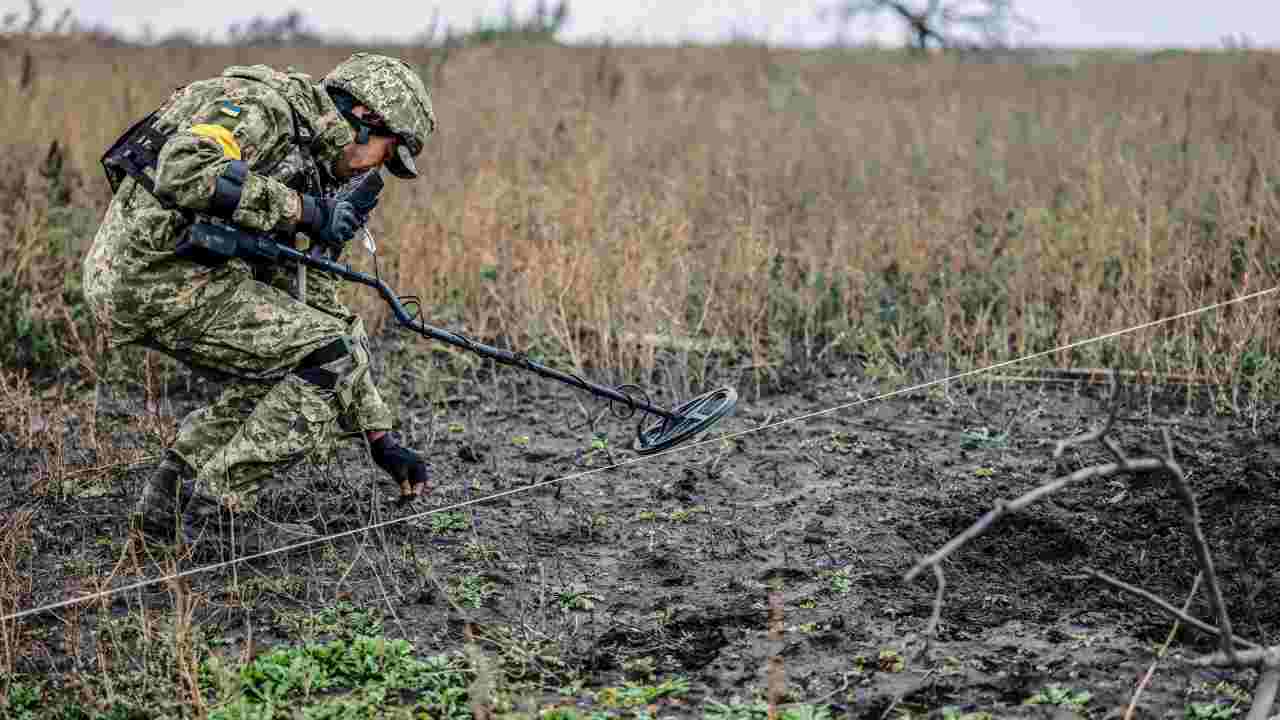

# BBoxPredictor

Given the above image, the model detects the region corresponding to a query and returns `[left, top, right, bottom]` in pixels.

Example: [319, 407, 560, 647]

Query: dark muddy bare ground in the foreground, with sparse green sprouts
[0, 343, 1280, 717]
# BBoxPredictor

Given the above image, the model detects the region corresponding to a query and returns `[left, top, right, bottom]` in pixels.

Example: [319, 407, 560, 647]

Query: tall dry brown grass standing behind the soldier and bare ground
[0, 40, 1280, 393]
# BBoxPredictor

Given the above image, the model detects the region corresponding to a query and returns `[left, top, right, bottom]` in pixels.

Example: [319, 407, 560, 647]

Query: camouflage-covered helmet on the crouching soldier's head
[323, 53, 435, 178]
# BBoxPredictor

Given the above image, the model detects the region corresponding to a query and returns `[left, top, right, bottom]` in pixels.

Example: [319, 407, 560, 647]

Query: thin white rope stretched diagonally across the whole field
[0, 286, 1280, 621]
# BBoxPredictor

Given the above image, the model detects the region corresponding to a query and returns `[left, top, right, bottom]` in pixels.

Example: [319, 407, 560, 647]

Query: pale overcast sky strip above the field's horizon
[10, 0, 1280, 49]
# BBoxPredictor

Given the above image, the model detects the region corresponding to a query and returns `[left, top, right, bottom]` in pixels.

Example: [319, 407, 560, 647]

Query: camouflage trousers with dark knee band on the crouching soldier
[140, 266, 393, 510]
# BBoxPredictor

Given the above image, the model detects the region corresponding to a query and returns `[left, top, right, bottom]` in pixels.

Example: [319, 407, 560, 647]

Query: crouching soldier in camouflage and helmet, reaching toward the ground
[84, 53, 435, 550]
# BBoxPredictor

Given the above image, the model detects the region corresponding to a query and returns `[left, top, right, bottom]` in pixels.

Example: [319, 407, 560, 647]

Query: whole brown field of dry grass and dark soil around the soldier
[0, 36, 1280, 720]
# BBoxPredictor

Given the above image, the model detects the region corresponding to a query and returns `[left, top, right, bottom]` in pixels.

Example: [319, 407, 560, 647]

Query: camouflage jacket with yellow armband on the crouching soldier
[83, 65, 355, 345]
